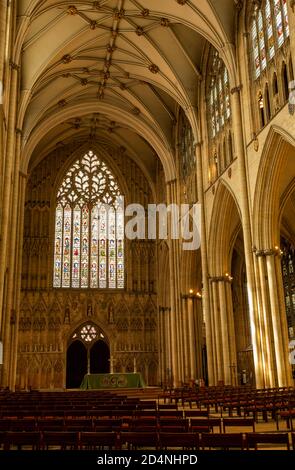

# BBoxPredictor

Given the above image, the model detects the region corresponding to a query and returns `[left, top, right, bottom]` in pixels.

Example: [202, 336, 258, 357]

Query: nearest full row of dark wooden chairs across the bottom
[0, 432, 295, 450]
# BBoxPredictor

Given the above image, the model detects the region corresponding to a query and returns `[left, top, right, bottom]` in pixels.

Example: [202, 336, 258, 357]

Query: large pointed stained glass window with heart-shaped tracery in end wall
[53, 151, 124, 289]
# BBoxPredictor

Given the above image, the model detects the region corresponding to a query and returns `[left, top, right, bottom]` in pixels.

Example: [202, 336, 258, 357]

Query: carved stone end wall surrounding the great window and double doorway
[16, 146, 158, 389]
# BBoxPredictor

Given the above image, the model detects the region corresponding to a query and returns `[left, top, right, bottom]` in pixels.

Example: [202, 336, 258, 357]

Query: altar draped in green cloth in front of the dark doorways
[80, 372, 145, 390]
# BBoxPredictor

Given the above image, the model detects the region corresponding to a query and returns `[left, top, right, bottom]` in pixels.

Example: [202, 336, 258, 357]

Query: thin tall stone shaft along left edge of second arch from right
[196, 143, 217, 385]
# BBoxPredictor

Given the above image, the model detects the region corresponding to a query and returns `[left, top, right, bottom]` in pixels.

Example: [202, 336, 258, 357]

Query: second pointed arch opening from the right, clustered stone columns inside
[207, 184, 254, 385]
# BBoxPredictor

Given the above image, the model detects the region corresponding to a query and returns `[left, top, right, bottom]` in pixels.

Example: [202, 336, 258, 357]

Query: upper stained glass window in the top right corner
[251, 0, 290, 78]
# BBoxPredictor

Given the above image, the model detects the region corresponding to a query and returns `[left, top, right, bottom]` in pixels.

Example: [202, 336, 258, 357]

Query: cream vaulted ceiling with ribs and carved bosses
[14, 0, 236, 179]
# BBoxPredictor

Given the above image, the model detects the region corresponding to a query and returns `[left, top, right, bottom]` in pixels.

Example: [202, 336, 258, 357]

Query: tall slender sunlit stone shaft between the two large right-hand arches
[231, 87, 263, 388]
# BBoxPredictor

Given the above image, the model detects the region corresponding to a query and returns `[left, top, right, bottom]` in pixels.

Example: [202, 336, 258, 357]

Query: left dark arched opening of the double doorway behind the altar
[66, 341, 87, 388]
